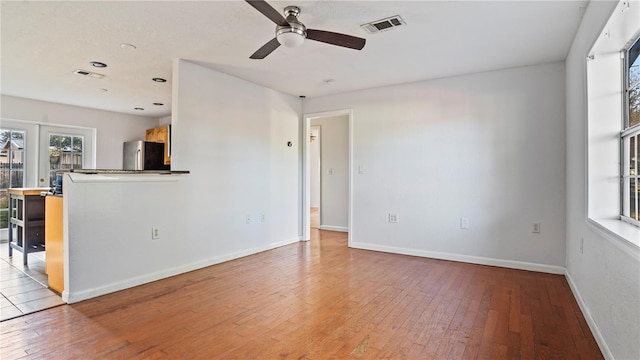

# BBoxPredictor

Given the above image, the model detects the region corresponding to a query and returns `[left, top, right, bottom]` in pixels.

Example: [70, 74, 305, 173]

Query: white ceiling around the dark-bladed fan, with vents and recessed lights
[0, 0, 588, 117]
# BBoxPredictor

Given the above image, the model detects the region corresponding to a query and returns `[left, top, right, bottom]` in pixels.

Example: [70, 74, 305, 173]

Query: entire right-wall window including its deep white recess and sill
[584, 1, 640, 247]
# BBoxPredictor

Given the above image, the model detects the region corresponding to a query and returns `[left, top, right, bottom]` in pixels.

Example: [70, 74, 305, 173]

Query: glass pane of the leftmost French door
[0, 129, 25, 229]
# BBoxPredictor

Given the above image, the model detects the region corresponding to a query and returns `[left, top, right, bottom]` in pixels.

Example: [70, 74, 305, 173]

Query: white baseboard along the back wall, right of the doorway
[350, 242, 565, 275]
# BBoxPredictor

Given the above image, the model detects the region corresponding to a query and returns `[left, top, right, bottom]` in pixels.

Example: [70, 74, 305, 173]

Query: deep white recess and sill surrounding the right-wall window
[585, 1, 640, 251]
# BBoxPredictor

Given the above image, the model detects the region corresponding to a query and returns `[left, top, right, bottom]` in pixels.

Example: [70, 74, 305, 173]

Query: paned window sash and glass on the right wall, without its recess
[620, 40, 640, 225]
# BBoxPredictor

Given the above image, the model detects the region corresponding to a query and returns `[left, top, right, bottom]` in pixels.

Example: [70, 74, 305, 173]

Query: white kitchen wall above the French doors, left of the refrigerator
[0, 95, 158, 169]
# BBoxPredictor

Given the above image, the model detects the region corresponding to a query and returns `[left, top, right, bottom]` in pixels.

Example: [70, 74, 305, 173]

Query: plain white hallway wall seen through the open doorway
[311, 115, 349, 231]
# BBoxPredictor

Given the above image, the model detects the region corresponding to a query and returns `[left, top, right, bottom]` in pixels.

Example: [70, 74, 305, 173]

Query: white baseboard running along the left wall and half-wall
[62, 237, 300, 304]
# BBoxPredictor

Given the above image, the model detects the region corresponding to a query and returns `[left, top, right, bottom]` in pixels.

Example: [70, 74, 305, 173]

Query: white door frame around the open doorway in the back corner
[301, 109, 353, 246]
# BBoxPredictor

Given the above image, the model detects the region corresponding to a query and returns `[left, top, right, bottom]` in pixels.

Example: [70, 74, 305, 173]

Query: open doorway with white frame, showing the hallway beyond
[302, 110, 352, 242]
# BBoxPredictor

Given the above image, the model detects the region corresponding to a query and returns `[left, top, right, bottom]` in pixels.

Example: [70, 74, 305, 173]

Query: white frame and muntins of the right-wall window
[620, 36, 640, 227]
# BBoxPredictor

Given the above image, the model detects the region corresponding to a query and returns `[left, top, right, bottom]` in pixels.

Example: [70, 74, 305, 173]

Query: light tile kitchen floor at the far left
[0, 243, 64, 321]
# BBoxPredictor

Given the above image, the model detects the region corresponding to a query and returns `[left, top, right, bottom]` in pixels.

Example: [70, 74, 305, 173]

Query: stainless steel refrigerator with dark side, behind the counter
[122, 140, 169, 170]
